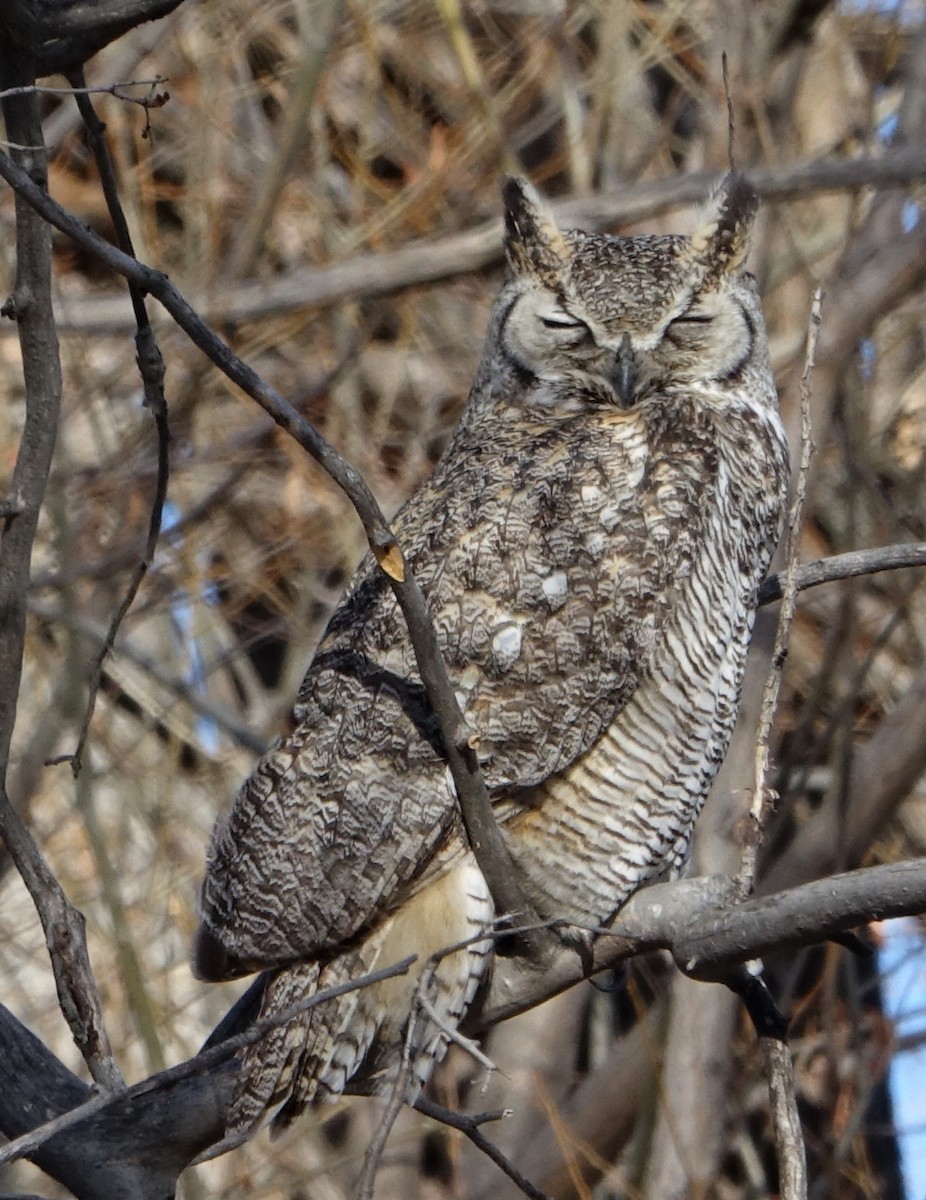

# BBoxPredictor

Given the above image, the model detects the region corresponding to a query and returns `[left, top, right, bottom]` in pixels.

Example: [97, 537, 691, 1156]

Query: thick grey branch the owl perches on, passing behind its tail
[0, 859, 926, 1200]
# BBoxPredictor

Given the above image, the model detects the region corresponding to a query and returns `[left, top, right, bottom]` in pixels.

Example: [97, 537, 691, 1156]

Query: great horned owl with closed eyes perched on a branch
[197, 175, 787, 1133]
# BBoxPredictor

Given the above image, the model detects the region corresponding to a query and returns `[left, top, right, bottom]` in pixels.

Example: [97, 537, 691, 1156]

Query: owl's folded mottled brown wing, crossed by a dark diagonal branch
[200, 401, 716, 977]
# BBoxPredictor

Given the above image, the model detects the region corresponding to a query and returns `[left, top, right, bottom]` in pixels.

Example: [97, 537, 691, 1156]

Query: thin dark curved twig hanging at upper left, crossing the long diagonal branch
[64, 68, 170, 775]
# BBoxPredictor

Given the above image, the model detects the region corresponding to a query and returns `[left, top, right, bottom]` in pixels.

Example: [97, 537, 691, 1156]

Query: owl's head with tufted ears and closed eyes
[500, 174, 768, 407]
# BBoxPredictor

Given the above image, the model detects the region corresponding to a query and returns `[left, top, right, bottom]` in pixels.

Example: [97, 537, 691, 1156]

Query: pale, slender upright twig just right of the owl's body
[736, 287, 823, 900]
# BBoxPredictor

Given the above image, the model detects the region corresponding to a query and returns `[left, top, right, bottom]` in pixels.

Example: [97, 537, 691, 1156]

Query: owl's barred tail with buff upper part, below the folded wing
[228, 857, 493, 1135]
